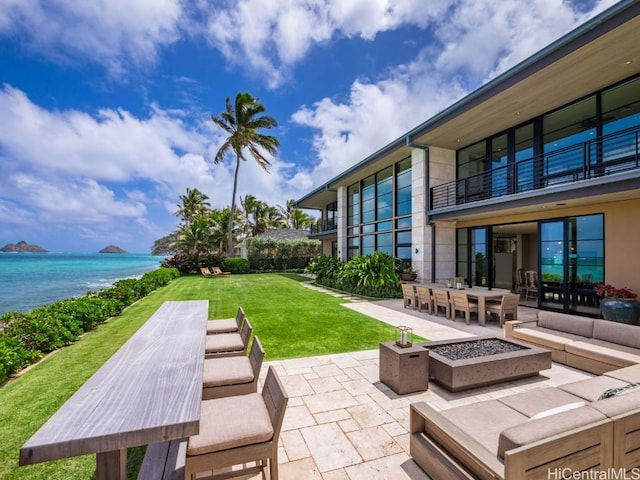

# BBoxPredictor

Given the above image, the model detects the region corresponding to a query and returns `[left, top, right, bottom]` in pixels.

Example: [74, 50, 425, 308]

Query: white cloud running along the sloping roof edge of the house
[290, 0, 614, 193]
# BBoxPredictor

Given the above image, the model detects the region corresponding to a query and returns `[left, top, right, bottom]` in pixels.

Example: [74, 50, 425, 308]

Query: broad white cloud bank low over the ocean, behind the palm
[0, 85, 294, 244]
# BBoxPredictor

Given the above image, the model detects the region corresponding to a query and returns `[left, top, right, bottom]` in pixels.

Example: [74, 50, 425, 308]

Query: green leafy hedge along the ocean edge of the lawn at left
[0, 268, 180, 383]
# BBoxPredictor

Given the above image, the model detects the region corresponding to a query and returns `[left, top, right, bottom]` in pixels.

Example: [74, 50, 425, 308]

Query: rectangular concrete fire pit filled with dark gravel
[421, 337, 551, 392]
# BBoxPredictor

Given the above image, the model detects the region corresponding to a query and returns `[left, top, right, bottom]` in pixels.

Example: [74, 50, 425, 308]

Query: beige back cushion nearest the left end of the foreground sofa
[498, 405, 607, 459]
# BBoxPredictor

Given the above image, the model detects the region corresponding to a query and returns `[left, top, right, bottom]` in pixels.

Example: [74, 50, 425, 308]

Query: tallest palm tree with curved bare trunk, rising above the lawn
[211, 93, 280, 256]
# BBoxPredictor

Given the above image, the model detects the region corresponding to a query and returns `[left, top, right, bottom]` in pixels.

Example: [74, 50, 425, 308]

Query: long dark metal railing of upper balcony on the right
[431, 127, 640, 210]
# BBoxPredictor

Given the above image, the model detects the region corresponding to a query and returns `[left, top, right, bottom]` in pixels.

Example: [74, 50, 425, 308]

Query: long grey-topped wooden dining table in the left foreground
[19, 300, 209, 480]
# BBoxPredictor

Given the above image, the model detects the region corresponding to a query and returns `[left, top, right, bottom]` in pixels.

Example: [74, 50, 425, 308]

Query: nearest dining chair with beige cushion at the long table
[184, 366, 288, 480]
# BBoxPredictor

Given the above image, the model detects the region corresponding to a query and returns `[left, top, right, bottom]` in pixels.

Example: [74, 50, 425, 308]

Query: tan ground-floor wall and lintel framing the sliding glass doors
[456, 199, 640, 293]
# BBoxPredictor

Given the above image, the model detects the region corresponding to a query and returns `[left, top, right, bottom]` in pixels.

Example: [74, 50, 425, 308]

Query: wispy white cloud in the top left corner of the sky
[0, 0, 185, 77]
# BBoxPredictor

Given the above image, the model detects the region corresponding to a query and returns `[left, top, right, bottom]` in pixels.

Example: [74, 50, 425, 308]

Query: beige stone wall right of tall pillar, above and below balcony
[421, 147, 456, 282]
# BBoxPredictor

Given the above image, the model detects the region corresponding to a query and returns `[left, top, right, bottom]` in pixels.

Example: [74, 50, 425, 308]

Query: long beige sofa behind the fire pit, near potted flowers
[505, 310, 640, 375]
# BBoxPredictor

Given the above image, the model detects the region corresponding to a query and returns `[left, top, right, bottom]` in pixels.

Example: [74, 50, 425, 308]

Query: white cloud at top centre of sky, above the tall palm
[202, 0, 449, 88]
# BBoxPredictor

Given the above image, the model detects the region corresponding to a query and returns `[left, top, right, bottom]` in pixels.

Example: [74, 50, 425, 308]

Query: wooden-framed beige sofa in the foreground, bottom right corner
[410, 365, 640, 480]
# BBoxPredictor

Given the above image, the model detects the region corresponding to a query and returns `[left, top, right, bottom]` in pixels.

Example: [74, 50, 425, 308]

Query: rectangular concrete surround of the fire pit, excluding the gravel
[420, 337, 551, 392]
